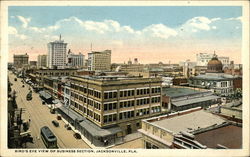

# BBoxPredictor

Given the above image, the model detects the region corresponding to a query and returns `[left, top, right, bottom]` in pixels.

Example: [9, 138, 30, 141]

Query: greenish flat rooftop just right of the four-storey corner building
[162, 88, 200, 97]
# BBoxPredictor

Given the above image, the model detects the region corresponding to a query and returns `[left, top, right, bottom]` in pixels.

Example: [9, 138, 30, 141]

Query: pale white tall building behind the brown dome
[196, 53, 230, 66]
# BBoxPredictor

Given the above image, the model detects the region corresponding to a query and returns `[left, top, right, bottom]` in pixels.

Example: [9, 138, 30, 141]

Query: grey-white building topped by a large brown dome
[189, 54, 238, 96]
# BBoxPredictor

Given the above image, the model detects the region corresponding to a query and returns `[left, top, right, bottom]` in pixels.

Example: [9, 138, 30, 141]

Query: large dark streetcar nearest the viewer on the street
[41, 126, 58, 148]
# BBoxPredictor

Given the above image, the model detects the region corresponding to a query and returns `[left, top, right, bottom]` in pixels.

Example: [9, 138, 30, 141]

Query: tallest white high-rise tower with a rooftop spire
[47, 35, 67, 69]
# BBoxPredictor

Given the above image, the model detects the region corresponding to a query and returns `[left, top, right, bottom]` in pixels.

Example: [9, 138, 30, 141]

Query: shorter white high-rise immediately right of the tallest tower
[67, 49, 84, 68]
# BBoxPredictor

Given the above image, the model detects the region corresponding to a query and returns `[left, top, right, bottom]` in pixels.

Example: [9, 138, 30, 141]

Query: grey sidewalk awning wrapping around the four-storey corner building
[57, 106, 122, 137]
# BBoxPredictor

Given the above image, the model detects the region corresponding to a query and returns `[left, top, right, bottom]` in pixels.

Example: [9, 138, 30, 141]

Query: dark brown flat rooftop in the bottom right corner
[195, 125, 242, 149]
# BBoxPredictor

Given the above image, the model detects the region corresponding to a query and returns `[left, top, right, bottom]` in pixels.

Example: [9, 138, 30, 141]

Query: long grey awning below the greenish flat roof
[172, 95, 220, 107]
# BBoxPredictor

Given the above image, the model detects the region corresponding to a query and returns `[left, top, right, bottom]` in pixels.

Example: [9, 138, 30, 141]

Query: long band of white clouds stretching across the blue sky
[9, 16, 241, 48]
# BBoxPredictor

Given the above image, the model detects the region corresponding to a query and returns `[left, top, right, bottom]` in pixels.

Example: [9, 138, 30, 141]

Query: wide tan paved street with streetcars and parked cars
[9, 72, 90, 148]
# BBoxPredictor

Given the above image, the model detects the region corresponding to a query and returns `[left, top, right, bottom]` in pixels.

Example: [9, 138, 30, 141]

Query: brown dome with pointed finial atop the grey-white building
[207, 54, 223, 73]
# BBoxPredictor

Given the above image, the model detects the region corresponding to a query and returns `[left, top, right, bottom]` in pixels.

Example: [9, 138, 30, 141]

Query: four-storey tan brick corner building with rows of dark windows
[65, 76, 161, 136]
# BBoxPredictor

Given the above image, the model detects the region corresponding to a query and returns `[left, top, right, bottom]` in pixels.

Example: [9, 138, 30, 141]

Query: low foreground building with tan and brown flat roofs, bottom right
[139, 108, 242, 149]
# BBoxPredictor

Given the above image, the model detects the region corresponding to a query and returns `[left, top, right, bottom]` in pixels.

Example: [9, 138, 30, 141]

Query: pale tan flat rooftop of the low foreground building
[152, 110, 226, 134]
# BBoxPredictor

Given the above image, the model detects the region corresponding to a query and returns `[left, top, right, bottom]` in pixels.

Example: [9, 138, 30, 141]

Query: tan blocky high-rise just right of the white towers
[88, 50, 111, 71]
